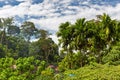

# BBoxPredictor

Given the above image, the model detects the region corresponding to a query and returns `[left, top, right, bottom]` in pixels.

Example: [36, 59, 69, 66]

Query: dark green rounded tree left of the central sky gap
[29, 37, 59, 63]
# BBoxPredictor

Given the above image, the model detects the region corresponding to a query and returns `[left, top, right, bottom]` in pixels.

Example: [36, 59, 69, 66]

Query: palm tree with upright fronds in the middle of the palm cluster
[73, 18, 87, 50]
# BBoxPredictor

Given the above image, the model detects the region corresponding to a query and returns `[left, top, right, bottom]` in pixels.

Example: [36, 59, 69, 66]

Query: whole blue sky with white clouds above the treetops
[0, 0, 120, 43]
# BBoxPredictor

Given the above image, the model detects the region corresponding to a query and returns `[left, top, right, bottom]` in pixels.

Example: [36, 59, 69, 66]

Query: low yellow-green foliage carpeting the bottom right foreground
[35, 63, 120, 80]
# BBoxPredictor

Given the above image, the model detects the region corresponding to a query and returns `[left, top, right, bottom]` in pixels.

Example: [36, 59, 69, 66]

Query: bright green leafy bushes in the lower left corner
[0, 57, 46, 80]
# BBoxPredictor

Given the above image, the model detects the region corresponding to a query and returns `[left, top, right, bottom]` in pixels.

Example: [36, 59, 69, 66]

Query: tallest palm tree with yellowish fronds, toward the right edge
[101, 13, 116, 43]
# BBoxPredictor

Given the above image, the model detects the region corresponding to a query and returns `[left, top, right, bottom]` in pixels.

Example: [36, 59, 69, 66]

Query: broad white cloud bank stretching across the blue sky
[0, 0, 120, 43]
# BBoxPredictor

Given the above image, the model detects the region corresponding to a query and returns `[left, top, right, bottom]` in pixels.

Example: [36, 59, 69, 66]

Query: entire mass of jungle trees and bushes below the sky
[0, 14, 120, 80]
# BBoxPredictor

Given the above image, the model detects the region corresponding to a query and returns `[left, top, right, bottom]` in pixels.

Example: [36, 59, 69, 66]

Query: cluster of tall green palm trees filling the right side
[57, 14, 120, 68]
